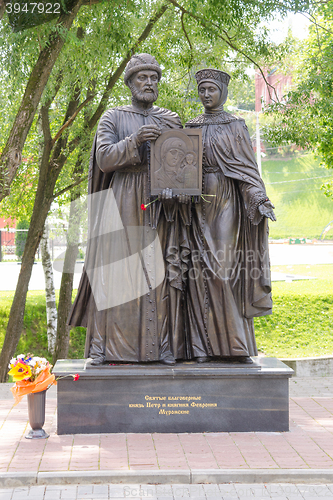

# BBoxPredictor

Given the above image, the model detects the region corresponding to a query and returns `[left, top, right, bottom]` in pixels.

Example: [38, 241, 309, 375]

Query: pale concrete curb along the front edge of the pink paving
[0, 469, 333, 488]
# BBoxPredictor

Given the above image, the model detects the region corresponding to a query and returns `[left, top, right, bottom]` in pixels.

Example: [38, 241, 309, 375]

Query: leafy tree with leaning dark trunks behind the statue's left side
[0, 0, 314, 381]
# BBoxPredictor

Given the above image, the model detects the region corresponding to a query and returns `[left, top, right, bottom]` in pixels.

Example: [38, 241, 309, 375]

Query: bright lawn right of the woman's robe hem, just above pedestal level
[255, 265, 333, 358]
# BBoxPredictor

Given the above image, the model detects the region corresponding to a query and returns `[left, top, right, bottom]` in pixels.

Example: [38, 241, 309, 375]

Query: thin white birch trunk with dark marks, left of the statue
[40, 222, 57, 354]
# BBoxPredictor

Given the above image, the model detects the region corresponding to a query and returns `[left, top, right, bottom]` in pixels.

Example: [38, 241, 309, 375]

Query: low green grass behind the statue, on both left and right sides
[0, 265, 333, 361]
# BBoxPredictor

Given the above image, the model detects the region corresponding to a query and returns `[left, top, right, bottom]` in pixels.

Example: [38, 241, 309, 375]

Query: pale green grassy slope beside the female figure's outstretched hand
[262, 153, 333, 239]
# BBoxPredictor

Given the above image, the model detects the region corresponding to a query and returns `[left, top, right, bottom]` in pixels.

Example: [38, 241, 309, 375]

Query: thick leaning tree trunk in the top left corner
[0, 0, 82, 201]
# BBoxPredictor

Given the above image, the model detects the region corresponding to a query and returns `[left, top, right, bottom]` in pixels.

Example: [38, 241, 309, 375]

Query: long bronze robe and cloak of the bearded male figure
[69, 106, 189, 362]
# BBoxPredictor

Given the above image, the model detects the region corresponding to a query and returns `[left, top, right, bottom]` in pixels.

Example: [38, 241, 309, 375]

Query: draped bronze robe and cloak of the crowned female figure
[186, 111, 272, 357]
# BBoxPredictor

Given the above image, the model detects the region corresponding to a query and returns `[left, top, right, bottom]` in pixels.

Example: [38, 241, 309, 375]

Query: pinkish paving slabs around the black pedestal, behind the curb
[0, 377, 333, 474]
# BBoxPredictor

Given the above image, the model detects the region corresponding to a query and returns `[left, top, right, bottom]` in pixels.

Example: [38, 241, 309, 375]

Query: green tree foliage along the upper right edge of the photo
[265, 2, 333, 195]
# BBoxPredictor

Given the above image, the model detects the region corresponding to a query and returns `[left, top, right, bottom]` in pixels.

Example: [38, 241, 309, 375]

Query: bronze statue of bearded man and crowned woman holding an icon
[69, 54, 275, 365]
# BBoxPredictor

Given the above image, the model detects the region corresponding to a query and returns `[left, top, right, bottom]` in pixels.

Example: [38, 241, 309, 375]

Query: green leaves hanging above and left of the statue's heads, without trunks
[0, 0, 308, 215]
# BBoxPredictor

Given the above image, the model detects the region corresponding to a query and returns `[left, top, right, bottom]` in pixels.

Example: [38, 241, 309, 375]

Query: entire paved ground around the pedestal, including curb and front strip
[0, 377, 333, 500]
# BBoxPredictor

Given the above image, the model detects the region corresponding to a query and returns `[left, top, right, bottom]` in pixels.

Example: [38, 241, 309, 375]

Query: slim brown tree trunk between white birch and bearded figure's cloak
[53, 190, 81, 363]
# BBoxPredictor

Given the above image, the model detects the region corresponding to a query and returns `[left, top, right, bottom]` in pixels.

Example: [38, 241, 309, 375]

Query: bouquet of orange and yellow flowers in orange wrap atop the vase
[8, 354, 57, 404]
